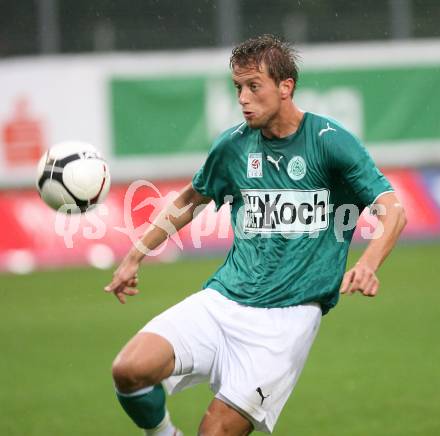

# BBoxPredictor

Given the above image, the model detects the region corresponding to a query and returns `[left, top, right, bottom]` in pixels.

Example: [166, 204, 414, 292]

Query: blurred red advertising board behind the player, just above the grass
[0, 170, 440, 272]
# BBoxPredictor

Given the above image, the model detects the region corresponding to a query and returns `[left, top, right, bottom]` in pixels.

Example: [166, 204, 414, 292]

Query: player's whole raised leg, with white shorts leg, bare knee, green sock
[113, 291, 219, 435]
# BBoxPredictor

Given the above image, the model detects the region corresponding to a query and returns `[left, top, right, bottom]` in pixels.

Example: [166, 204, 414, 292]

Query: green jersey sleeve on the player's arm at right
[325, 130, 394, 207]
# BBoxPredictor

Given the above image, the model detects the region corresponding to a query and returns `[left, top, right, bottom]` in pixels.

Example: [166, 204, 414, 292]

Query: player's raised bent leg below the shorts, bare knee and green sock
[112, 333, 179, 436]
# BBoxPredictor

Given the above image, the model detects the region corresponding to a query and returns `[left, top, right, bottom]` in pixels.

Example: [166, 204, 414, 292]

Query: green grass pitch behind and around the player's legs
[0, 244, 440, 436]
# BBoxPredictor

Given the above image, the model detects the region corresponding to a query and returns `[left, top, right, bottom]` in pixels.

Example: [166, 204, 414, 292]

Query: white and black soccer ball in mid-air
[37, 141, 110, 213]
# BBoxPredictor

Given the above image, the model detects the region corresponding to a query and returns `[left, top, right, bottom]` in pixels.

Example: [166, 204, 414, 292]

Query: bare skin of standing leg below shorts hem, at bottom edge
[199, 398, 253, 436]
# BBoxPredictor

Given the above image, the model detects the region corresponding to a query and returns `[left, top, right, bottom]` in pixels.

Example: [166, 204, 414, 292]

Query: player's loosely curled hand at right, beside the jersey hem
[339, 262, 379, 297]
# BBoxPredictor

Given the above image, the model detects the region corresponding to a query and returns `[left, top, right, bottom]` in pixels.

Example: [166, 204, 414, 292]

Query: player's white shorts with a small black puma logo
[141, 289, 321, 433]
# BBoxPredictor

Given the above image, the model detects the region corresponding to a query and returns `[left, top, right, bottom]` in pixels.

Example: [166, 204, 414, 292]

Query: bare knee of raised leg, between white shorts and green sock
[113, 332, 174, 391]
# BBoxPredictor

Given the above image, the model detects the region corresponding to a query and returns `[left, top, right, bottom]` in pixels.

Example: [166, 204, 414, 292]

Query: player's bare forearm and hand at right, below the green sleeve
[340, 192, 406, 297]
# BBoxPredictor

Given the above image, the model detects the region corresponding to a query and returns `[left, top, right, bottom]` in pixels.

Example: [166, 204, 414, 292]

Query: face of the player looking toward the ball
[232, 64, 281, 129]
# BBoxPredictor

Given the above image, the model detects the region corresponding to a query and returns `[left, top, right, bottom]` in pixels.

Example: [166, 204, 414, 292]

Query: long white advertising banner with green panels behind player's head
[0, 41, 440, 188]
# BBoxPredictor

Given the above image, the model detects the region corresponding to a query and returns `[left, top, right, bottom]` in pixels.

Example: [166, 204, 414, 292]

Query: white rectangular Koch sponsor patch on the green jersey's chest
[241, 189, 329, 233]
